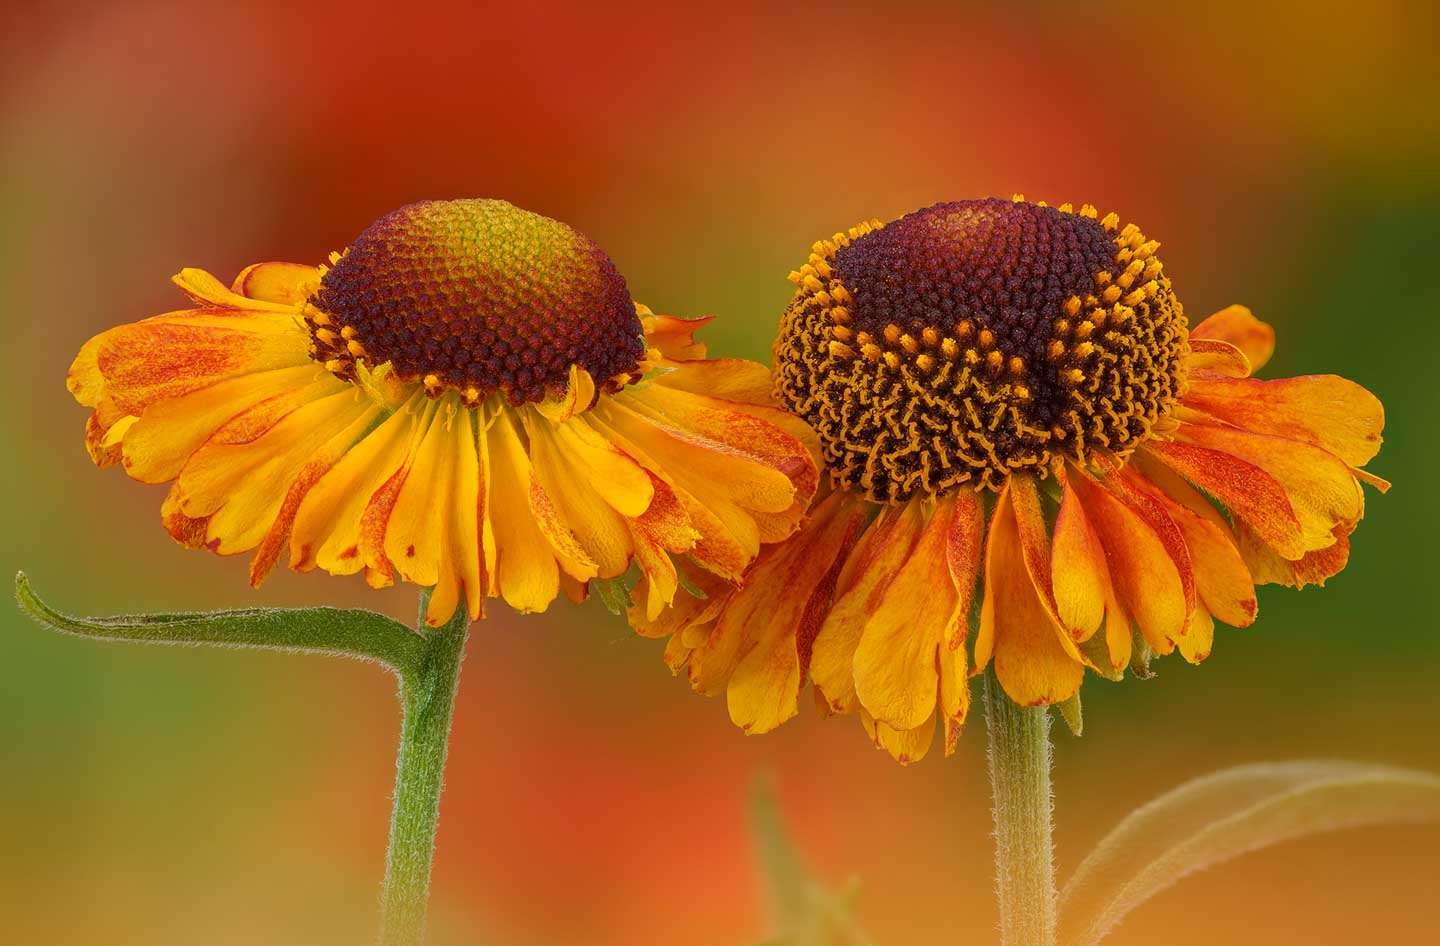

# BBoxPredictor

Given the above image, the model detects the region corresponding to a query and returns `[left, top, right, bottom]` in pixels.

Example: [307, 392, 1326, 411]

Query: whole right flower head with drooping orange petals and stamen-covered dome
[631, 196, 1388, 762]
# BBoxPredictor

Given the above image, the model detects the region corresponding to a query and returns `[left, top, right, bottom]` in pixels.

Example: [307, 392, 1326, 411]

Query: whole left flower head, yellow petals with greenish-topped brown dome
[68, 200, 816, 625]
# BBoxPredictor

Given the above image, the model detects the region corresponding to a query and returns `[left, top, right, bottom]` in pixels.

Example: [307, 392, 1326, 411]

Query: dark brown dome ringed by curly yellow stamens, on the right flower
[775, 199, 1187, 501]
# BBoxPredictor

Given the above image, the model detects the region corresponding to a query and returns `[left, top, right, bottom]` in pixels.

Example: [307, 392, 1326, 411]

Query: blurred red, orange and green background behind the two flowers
[0, 0, 1440, 946]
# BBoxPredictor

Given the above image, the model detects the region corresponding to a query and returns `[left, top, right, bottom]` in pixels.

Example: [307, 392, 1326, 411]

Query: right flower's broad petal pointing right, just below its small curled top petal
[1184, 374, 1385, 467]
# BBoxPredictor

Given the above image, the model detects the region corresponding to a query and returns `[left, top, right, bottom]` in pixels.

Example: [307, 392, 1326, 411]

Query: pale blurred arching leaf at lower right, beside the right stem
[1060, 760, 1440, 946]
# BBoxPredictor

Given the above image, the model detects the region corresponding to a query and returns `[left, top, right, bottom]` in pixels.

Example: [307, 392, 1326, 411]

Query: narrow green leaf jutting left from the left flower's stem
[14, 572, 425, 674]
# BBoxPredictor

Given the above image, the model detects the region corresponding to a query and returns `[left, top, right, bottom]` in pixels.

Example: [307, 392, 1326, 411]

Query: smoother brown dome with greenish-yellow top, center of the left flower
[307, 200, 645, 405]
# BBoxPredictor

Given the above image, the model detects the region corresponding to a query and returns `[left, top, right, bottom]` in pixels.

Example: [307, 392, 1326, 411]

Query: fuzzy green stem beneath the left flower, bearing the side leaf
[380, 590, 469, 946]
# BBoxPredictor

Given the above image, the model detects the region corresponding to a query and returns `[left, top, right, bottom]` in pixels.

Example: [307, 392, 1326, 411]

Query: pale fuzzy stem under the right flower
[985, 670, 1056, 946]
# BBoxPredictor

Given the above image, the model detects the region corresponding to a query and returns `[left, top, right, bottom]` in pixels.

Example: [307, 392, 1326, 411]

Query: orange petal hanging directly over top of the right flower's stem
[975, 488, 1082, 706]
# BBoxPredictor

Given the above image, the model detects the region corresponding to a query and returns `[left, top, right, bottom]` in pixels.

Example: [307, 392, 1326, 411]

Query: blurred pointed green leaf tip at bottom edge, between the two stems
[750, 778, 870, 946]
